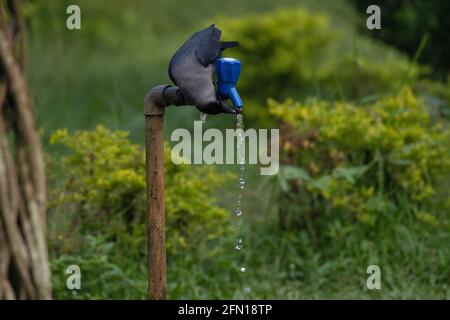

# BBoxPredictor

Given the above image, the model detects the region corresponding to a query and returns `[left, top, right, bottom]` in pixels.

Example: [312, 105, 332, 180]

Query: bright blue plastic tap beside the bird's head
[216, 58, 244, 108]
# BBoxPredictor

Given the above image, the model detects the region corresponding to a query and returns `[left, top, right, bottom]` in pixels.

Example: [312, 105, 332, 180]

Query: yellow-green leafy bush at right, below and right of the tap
[269, 89, 450, 225]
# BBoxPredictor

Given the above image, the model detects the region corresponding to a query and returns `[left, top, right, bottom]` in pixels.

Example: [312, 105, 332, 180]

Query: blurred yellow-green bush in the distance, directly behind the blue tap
[218, 9, 336, 97]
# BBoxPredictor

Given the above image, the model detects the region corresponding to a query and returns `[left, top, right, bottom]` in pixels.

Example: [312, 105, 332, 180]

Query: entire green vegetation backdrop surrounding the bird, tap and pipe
[26, 0, 450, 299]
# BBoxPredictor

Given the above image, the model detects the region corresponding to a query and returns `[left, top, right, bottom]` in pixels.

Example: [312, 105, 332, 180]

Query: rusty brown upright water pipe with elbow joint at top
[144, 85, 184, 300]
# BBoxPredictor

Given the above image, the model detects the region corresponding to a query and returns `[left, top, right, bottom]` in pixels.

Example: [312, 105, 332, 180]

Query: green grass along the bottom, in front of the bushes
[53, 215, 450, 299]
